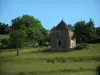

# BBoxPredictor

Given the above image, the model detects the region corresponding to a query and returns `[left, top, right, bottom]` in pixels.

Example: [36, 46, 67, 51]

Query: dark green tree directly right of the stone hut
[74, 19, 96, 43]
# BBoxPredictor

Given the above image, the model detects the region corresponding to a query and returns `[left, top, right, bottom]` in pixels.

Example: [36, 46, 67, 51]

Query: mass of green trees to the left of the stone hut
[0, 15, 50, 49]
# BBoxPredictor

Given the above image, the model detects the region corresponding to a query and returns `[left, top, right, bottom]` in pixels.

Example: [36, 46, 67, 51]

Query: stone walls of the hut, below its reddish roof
[51, 29, 76, 51]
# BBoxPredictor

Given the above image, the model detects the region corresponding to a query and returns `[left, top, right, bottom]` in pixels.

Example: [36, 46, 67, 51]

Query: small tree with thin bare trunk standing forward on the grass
[9, 30, 26, 56]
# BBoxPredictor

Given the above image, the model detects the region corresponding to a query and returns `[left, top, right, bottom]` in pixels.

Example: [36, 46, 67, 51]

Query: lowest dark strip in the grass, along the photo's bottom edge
[4, 68, 95, 75]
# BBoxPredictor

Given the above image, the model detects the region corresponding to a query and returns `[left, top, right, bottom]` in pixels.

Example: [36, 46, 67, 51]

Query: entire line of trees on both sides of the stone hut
[0, 15, 100, 49]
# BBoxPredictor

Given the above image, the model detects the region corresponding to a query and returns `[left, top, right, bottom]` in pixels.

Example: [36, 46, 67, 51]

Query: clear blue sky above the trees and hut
[0, 0, 100, 29]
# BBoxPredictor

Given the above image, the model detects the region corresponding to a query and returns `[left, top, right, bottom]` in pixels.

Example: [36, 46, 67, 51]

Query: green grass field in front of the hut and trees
[0, 44, 100, 75]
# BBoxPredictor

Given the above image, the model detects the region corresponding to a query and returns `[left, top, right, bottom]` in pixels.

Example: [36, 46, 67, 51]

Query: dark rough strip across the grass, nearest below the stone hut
[44, 56, 100, 63]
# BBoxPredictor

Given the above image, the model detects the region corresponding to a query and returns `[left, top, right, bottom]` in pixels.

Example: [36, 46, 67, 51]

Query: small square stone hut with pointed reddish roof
[50, 20, 76, 51]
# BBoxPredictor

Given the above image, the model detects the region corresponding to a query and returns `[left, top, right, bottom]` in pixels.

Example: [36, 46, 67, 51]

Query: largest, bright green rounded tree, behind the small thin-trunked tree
[12, 15, 47, 46]
